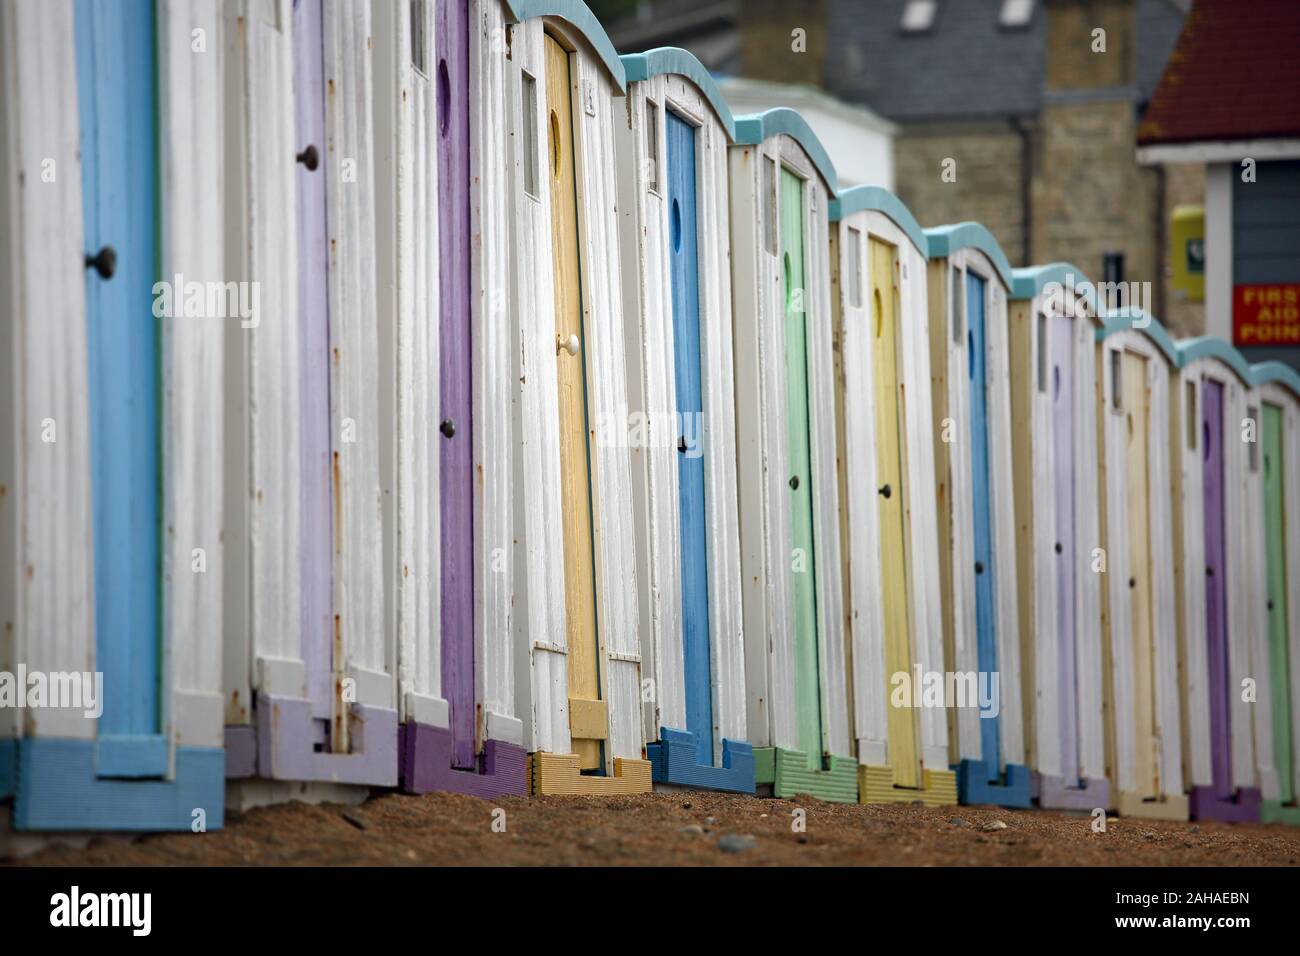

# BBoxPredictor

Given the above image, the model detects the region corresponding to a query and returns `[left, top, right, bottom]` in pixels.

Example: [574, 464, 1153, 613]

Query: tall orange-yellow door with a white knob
[546, 36, 608, 770]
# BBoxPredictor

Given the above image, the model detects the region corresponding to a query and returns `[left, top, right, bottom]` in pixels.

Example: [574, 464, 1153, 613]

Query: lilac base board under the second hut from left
[226, 693, 398, 787]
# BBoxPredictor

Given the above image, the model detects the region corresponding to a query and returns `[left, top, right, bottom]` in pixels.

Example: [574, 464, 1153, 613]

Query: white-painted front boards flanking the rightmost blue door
[930, 246, 1024, 763]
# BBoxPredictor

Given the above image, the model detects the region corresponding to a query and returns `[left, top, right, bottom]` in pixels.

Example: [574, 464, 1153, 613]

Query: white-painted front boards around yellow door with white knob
[509, 11, 644, 775]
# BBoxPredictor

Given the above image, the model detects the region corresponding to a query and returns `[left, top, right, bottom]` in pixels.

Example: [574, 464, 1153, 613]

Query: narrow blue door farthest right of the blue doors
[966, 272, 1001, 780]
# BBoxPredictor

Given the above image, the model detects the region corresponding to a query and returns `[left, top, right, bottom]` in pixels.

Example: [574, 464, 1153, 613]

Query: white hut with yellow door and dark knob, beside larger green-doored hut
[831, 186, 957, 805]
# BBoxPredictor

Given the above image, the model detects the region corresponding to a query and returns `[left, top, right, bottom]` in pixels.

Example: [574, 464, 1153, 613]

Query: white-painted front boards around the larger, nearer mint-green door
[731, 134, 850, 756]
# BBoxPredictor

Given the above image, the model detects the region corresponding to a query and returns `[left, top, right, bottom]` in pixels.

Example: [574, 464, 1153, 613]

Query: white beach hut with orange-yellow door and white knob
[491, 0, 651, 793]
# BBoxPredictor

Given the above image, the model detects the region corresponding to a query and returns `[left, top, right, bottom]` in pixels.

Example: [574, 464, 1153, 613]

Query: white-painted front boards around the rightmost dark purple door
[1170, 358, 1278, 799]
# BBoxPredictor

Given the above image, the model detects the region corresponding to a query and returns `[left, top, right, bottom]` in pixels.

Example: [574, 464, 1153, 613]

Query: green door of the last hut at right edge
[1260, 405, 1296, 804]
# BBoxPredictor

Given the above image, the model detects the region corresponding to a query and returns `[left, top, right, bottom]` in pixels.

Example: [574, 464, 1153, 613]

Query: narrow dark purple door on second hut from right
[1201, 378, 1232, 799]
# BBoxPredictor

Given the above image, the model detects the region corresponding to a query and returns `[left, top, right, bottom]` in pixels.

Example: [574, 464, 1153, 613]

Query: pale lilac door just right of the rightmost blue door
[1047, 315, 1079, 787]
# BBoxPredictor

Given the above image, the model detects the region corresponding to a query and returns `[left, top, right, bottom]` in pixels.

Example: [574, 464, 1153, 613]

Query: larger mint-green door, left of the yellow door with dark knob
[780, 169, 822, 769]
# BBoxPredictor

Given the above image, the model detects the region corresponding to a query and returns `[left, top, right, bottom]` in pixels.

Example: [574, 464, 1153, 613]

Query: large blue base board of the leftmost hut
[13, 739, 226, 830]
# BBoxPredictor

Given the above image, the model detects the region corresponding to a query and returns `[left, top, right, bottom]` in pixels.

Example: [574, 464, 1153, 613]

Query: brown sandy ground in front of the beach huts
[10, 792, 1300, 866]
